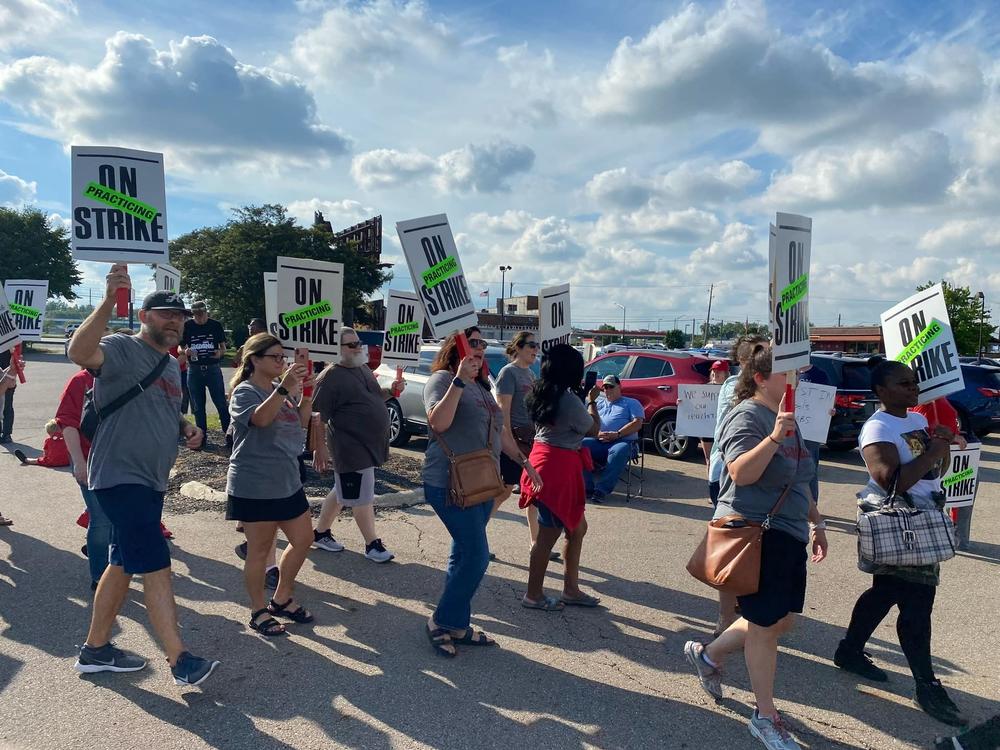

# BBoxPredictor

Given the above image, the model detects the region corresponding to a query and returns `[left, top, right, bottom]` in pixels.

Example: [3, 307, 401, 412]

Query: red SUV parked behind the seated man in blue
[587, 349, 715, 458]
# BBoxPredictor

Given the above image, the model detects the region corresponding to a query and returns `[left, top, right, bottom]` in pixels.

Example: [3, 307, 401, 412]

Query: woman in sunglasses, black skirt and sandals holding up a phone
[226, 333, 313, 636]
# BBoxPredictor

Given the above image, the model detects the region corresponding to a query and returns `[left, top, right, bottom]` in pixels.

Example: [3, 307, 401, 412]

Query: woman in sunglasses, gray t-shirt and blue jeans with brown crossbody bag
[423, 326, 542, 657]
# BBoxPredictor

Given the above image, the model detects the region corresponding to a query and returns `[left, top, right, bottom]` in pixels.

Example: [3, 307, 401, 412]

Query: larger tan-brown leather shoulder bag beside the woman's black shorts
[687, 485, 791, 596]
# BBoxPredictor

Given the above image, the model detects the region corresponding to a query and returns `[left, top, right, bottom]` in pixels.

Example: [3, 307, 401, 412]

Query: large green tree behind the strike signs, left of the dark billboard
[170, 204, 391, 343]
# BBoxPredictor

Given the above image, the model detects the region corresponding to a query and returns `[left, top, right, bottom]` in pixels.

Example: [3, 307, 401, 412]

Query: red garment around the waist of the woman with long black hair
[517, 440, 594, 531]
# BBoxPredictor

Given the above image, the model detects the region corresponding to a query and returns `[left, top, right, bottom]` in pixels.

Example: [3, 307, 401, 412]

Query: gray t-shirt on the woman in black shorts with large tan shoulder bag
[714, 399, 816, 543]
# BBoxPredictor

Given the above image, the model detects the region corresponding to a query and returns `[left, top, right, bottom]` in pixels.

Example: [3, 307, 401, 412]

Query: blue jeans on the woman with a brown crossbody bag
[424, 484, 493, 630]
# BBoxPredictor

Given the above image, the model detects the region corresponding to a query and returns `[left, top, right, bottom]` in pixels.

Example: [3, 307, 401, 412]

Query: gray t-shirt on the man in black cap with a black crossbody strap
[87, 333, 182, 492]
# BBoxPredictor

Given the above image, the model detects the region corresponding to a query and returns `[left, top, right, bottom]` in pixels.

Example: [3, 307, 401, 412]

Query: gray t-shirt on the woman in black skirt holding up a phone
[226, 380, 306, 500]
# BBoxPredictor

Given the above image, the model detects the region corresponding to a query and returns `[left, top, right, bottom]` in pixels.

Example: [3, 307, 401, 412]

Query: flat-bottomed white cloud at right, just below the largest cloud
[758, 132, 955, 210]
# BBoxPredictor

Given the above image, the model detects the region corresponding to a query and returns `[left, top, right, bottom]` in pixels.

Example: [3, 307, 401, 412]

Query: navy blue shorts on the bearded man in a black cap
[94, 484, 170, 575]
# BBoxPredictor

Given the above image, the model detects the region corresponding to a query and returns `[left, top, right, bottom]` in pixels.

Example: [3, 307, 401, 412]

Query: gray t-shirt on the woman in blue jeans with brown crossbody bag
[424, 370, 503, 488]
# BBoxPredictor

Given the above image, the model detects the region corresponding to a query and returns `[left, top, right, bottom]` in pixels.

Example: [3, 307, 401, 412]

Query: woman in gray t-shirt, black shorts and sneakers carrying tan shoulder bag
[684, 344, 827, 747]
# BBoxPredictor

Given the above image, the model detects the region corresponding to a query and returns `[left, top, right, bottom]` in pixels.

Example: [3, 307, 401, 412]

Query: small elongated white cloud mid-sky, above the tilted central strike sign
[351, 140, 535, 193]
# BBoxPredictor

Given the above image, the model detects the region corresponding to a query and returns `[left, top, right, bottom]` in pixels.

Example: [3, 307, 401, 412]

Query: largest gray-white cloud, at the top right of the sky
[586, 0, 984, 153]
